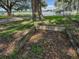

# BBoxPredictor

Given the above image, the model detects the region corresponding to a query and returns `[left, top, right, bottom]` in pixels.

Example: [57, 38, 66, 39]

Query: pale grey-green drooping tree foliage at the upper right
[56, 0, 79, 14]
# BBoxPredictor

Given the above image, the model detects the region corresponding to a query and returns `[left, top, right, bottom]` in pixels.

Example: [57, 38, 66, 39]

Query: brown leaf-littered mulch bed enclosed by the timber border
[17, 30, 75, 59]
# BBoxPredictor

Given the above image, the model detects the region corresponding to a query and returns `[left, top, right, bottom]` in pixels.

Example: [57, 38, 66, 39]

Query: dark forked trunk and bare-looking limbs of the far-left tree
[0, 0, 17, 16]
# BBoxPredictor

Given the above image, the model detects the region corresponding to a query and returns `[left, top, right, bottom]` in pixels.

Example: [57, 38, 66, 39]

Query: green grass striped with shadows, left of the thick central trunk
[0, 21, 33, 41]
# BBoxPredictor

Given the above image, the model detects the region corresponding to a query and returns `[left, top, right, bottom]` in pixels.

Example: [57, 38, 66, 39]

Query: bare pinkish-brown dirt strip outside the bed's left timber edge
[0, 30, 31, 56]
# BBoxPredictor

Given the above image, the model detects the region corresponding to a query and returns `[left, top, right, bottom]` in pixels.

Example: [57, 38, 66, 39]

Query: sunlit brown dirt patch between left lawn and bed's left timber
[0, 30, 29, 55]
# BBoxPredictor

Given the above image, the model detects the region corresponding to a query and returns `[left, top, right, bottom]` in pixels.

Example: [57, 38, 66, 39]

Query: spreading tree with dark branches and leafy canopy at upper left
[0, 0, 27, 16]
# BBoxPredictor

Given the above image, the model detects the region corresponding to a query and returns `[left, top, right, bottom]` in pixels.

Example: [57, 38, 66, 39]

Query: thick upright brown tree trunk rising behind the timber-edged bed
[31, 0, 47, 20]
